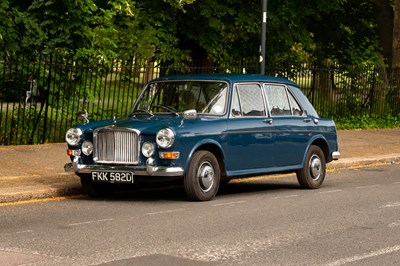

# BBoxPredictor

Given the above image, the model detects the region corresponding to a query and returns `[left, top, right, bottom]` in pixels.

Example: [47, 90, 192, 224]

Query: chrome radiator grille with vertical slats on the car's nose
[93, 128, 139, 164]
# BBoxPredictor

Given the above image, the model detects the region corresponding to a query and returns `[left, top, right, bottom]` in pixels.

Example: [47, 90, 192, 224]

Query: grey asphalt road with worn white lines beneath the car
[0, 165, 400, 266]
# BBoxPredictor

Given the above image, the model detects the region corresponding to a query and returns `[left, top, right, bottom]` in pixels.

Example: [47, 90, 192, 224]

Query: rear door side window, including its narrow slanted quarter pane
[264, 84, 303, 116]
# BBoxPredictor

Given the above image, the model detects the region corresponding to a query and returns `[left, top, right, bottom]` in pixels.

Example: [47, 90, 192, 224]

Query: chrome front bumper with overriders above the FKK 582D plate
[64, 157, 183, 177]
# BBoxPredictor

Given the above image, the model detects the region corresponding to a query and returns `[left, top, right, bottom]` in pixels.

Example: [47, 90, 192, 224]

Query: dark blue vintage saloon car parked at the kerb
[65, 74, 340, 201]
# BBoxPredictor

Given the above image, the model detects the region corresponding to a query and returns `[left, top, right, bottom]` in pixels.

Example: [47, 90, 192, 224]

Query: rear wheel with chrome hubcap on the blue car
[297, 145, 326, 189]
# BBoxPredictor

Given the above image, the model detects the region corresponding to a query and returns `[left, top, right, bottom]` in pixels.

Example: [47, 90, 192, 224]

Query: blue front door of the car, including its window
[224, 83, 274, 175]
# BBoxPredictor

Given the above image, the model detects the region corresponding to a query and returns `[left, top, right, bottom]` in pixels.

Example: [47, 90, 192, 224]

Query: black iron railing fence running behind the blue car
[0, 55, 400, 145]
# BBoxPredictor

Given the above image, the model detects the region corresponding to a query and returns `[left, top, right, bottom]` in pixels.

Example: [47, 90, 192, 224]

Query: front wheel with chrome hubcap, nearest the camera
[183, 151, 221, 201]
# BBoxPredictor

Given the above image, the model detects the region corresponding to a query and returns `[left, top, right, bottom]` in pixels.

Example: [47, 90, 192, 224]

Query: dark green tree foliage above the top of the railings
[0, 0, 392, 65]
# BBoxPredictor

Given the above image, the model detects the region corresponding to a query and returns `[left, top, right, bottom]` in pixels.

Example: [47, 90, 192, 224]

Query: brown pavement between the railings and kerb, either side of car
[0, 128, 400, 203]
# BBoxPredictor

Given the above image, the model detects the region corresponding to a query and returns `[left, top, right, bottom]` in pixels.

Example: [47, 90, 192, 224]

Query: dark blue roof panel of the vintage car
[153, 74, 298, 87]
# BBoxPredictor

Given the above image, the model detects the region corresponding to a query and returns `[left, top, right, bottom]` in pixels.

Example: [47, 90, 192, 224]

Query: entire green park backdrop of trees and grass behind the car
[0, 0, 400, 144]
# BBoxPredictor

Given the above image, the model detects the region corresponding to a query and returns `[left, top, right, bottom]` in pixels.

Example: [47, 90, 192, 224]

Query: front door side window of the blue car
[231, 84, 265, 117]
